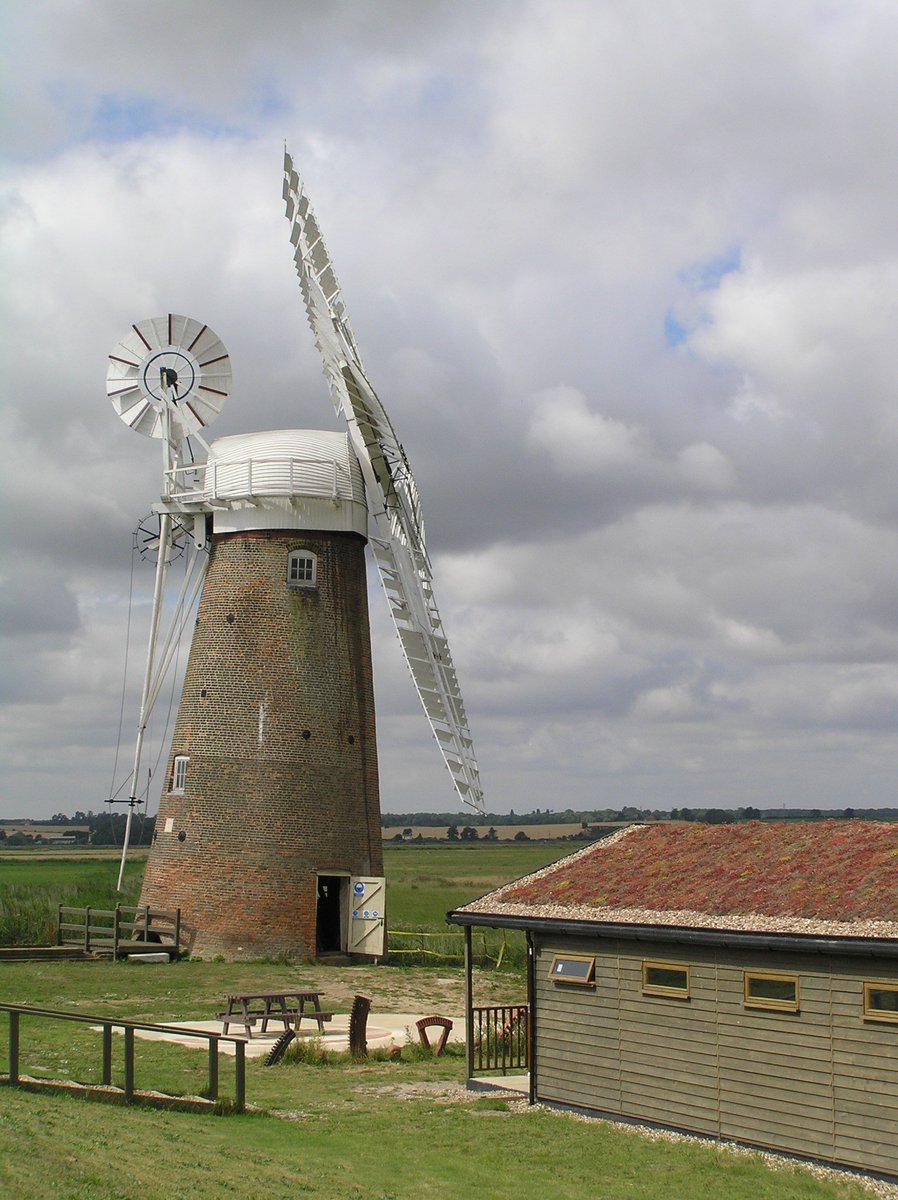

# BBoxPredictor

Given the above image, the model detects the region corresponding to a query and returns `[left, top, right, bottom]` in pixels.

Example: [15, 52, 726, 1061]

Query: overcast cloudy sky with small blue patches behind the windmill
[0, 0, 898, 816]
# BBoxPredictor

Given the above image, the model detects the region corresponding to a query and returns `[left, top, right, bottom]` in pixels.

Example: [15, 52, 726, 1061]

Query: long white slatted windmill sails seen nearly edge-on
[283, 151, 483, 811]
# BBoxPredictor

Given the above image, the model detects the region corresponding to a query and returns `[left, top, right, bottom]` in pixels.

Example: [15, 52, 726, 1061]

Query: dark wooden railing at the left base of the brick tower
[56, 905, 181, 958]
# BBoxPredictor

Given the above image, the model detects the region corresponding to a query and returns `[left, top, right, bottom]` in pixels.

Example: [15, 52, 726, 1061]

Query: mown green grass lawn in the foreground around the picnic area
[0, 962, 864, 1200]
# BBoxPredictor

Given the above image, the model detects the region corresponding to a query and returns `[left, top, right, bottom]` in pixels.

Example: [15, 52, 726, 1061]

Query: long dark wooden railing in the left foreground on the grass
[0, 1003, 246, 1112]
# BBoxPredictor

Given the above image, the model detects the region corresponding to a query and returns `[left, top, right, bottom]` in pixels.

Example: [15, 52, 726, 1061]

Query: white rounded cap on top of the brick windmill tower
[204, 430, 367, 536]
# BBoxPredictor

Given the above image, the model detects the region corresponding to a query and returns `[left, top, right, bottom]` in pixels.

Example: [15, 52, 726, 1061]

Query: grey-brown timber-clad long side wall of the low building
[534, 938, 898, 1174]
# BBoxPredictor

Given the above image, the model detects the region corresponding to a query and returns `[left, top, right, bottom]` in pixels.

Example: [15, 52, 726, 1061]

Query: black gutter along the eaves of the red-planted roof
[445, 908, 898, 959]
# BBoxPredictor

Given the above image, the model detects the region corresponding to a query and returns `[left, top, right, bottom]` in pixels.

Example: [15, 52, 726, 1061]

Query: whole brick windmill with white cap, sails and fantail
[107, 155, 483, 958]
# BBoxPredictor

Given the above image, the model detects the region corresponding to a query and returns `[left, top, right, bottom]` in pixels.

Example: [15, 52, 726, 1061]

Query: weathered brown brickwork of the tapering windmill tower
[140, 530, 383, 958]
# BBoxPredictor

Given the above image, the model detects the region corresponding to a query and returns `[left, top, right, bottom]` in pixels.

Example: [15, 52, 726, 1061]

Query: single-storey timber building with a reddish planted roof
[448, 821, 898, 1175]
